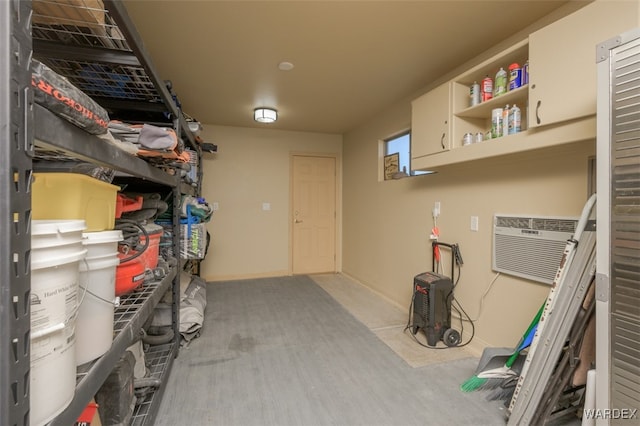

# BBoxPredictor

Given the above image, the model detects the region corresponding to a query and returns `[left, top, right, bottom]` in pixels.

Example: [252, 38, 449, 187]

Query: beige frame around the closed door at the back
[288, 151, 342, 275]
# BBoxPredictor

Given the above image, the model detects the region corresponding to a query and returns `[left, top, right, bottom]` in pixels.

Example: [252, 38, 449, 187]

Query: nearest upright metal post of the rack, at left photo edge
[0, 1, 33, 425]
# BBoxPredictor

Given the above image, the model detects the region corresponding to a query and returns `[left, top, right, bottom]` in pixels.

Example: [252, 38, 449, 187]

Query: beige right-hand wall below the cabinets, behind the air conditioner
[342, 97, 595, 352]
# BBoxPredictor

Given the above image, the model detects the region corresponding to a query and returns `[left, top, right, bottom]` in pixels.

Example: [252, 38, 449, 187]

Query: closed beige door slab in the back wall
[291, 155, 336, 274]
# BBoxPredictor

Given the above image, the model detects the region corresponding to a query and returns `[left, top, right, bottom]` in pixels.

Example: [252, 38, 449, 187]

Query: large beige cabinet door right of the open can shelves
[528, 1, 638, 128]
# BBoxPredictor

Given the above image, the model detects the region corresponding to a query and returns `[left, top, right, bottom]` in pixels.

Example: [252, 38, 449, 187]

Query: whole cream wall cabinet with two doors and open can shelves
[412, 0, 640, 170]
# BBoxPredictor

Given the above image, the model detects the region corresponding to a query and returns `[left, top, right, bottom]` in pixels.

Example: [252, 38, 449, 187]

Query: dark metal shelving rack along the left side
[0, 0, 201, 426]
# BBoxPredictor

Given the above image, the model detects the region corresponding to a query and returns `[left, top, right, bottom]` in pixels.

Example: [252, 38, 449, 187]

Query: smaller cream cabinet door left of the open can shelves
[411, 83, 451, 158]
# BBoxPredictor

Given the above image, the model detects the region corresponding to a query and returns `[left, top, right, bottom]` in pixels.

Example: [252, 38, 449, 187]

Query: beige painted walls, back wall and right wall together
[202, 3, 595, 354]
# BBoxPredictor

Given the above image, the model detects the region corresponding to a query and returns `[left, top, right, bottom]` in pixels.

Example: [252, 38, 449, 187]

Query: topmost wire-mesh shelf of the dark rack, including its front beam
[32, 0, 198, 150]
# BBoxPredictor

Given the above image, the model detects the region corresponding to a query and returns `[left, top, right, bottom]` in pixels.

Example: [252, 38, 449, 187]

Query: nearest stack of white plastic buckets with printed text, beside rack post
[29, 220, 87, 426]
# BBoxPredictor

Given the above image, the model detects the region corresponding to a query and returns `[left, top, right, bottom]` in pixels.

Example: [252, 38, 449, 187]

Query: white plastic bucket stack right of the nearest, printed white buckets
[76, 231, 122, 365]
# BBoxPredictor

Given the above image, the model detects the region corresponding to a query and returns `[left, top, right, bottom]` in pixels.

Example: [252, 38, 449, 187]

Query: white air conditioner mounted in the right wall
[492, 215, 578, 284]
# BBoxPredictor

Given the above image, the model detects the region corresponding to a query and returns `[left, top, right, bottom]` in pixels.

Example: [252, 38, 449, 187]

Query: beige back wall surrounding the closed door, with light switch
[202, 124, 342, 281]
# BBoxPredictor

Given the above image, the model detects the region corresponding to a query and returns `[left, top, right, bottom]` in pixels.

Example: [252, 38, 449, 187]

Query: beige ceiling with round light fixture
[125, 0, 566, 134]
